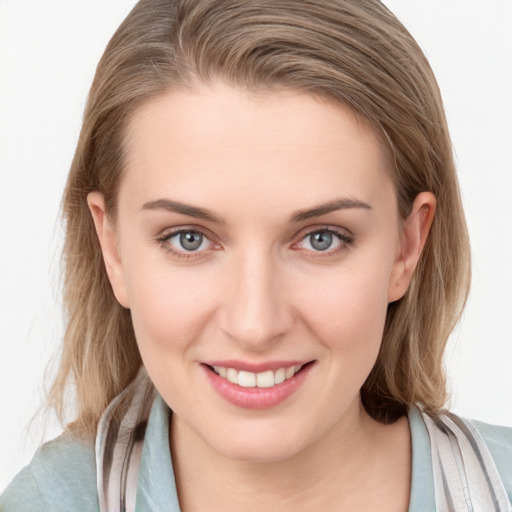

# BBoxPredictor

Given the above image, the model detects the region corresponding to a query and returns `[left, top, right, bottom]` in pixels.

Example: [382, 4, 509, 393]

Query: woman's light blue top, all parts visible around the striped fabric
[0, 396, 512, 512]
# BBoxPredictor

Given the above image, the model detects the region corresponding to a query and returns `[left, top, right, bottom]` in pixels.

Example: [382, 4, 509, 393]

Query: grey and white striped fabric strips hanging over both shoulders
[96, 368, 512, 512]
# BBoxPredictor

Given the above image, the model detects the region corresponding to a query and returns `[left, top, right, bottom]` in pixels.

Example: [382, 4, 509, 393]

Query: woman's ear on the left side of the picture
[87, 192, 129, 308]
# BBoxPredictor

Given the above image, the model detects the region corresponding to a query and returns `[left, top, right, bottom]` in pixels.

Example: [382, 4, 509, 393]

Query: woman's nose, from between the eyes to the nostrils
[220, 252, 294, 352]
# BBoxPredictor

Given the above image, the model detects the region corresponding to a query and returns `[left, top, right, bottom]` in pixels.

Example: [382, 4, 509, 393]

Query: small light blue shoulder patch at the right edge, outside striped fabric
[471, 420, 512, 502]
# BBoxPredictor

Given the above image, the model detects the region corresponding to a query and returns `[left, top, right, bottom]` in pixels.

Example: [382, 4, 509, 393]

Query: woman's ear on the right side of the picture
[388, 192, 436, 302]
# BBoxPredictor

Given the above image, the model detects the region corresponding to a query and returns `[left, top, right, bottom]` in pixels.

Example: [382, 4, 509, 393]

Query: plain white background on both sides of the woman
[0, 0, 512, 490]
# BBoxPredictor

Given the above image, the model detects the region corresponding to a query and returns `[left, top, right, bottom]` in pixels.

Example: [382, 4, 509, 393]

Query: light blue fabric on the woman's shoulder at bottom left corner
[0, 432, 99, 512]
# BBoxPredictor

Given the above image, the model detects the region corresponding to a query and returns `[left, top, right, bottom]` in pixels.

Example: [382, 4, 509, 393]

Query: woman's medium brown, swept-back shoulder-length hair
[49, 0, 470, 432]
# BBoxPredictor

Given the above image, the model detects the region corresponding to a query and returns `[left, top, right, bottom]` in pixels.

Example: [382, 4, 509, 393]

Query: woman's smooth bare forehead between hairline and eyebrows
[121, 84, 391, 218]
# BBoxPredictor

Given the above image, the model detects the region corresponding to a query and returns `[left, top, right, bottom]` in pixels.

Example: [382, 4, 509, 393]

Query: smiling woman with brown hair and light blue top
[2, 0, 512, 511]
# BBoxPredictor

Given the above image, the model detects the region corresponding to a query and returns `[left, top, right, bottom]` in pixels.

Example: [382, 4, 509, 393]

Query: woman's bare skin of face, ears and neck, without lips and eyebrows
[88, 83, 435, 512]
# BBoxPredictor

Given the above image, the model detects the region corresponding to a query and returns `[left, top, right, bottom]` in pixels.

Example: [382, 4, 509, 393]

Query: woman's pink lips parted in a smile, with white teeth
[202, 361, 314, 409]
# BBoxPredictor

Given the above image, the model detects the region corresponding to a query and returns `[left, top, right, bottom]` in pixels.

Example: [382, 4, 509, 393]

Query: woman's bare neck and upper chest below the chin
[170, 400, 411, 512]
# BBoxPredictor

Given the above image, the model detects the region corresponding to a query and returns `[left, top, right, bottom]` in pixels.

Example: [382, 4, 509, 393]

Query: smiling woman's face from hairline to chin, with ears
[90, 84, 430, 460]
